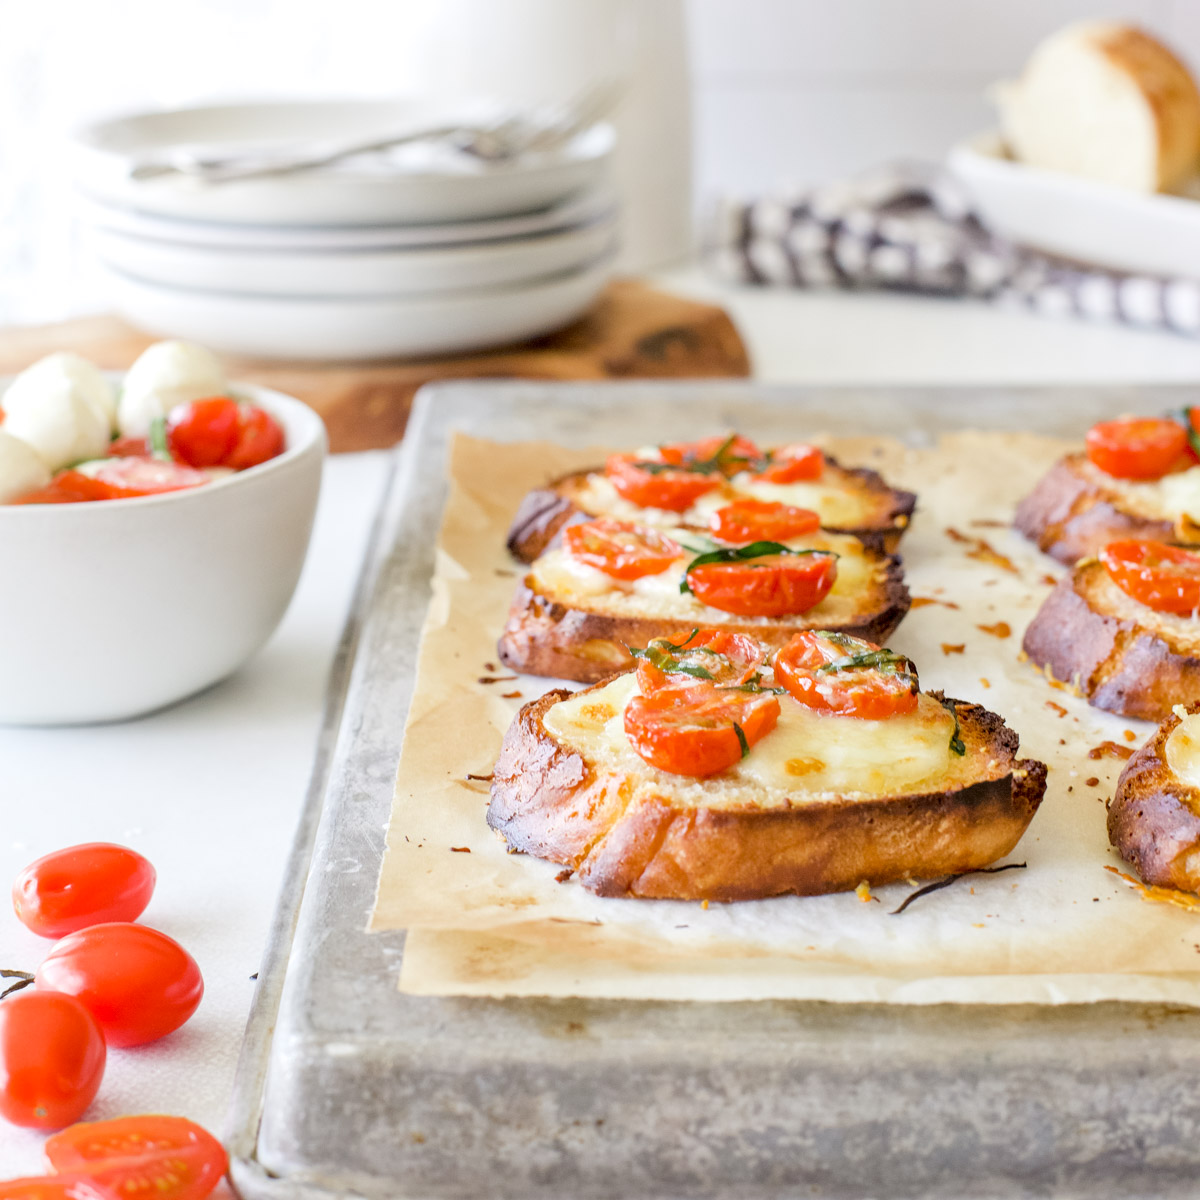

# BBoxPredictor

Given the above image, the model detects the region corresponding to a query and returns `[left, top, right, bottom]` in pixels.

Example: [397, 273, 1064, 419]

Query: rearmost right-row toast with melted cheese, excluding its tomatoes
[1014, 454, 1200, 564]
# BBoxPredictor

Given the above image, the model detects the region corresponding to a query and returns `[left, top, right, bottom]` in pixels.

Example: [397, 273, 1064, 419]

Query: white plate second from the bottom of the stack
[82, 218, 614, 298]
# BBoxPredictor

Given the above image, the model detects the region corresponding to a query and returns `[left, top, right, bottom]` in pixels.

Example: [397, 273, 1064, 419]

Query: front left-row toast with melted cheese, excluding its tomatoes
[487, 672, 1045, 900]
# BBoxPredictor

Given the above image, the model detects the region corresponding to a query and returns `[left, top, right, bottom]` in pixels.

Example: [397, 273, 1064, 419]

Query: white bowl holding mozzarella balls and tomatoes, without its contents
[0, 385, 325, 725]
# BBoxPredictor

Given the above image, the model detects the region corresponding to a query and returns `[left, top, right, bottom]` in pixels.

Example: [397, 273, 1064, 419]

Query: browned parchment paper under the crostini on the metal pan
[371, 431, 1200, 1004]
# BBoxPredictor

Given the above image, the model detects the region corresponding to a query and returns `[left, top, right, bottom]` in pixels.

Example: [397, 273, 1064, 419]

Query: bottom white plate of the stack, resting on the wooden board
[104, 254, 613, 361]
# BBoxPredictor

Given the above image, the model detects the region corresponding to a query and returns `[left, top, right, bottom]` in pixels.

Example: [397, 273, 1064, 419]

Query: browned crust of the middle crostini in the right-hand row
[1021, 562, 1200, 721]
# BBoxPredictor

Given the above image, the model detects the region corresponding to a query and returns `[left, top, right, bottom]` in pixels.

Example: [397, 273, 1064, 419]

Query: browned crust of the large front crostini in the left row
[487, 690, 1046, 900]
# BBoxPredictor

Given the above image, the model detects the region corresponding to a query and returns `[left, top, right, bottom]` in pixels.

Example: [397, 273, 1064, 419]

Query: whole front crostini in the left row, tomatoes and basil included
[487, 630, 1045, 900]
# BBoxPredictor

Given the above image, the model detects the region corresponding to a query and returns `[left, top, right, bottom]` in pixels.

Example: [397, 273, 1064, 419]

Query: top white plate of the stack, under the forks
[76, 101, 614, 226]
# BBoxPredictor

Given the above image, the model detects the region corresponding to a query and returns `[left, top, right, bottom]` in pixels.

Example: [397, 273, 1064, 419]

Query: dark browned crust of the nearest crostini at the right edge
[1109, 704, 1200, 892]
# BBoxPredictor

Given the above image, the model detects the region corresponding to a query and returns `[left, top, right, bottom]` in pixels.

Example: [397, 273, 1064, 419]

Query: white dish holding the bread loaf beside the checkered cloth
[949, 133, 1200, 278]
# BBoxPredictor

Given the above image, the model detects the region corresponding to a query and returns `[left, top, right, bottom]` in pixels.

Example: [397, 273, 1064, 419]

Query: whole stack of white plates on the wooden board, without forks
[77, 102, 617, 359]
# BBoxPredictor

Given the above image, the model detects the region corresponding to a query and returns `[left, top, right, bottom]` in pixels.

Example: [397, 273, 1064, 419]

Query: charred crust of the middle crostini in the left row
[497, 556, 912, 683]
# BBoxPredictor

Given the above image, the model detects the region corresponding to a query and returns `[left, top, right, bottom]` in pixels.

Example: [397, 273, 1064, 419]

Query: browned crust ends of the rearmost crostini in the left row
[508, 457, 917, 563]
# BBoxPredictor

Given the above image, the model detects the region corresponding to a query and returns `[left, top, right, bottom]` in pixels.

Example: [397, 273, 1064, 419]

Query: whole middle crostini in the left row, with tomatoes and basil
[498, 499, 910, 683]
